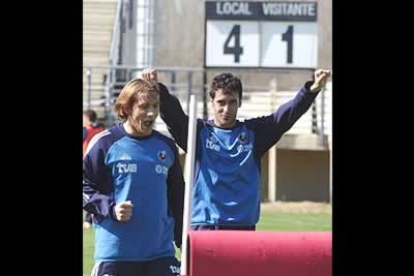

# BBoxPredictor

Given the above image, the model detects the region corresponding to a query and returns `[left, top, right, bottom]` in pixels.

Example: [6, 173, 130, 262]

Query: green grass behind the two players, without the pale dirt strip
[83, 210, 332, 276]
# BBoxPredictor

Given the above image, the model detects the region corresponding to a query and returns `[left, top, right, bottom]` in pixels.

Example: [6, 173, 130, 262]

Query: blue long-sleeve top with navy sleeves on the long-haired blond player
[83, 124, 184, 261]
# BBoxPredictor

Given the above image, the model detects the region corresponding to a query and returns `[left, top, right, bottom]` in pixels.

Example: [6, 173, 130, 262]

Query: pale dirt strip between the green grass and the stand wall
[262, 201, 332, 214]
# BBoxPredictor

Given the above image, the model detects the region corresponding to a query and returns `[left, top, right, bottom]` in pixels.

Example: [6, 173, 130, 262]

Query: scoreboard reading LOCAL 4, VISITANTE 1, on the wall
[205, 1, 318, 68]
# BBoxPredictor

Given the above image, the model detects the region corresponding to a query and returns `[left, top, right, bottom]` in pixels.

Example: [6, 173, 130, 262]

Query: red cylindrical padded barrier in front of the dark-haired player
[188, 231, 332, 276]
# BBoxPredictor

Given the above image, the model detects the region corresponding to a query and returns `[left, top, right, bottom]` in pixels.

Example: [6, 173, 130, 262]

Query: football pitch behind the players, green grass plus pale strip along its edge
[83, 203, 332, 276]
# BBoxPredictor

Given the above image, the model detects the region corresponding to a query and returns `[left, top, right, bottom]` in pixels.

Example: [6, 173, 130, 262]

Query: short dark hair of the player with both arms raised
[209, 73, 243, 103]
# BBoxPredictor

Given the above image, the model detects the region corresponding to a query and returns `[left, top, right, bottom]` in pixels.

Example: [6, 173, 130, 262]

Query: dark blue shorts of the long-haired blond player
[91, 257, 180, 276]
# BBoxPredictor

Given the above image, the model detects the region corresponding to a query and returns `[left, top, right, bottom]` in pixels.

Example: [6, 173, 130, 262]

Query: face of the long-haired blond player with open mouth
[126, 91, 160, 136]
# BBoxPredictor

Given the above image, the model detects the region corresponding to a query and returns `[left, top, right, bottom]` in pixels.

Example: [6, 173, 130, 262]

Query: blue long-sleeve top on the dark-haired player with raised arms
[160, 82, 319, 226]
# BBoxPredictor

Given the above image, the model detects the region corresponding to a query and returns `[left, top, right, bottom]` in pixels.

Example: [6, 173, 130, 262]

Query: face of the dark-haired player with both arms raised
[212, 89, 240, 128]
